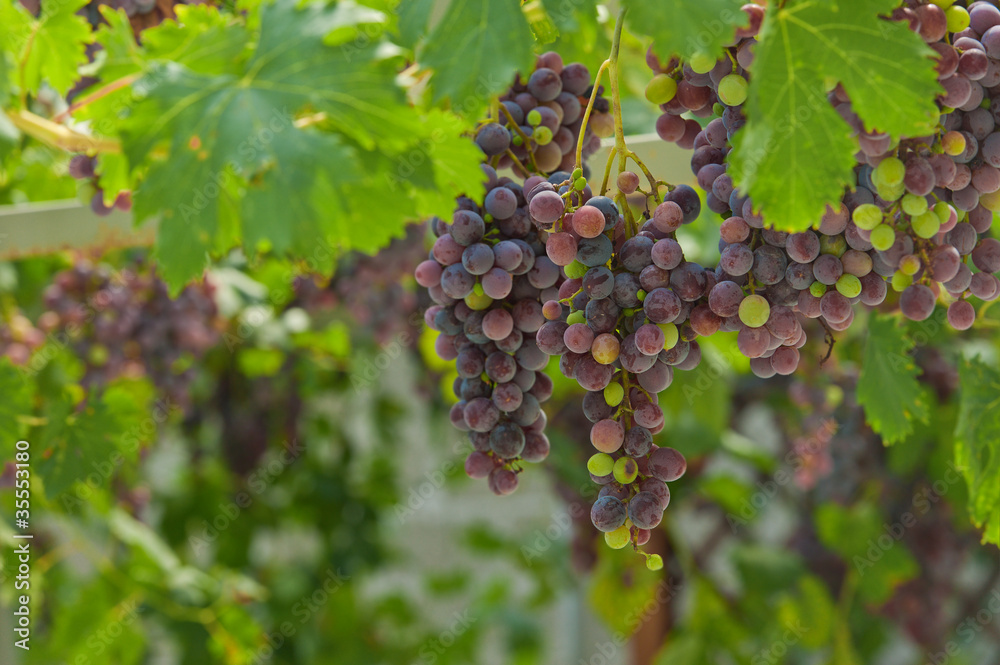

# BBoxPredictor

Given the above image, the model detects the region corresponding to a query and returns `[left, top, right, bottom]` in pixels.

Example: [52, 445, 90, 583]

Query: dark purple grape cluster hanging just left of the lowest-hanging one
[414, 164, 562, 495]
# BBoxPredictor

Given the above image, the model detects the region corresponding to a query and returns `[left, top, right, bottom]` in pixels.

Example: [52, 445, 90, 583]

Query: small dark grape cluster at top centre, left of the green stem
[476, 51, 614, 178]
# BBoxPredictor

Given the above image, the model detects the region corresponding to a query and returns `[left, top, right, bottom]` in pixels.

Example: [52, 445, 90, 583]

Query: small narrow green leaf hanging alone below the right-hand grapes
[857, 314, 929, 444]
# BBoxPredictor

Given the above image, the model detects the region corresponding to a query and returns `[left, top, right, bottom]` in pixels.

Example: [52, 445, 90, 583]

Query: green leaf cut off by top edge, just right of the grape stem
[622, 0, 749, 58]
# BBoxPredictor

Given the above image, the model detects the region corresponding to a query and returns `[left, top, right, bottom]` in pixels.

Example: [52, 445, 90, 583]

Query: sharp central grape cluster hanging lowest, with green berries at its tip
[524, 165, 692, 548]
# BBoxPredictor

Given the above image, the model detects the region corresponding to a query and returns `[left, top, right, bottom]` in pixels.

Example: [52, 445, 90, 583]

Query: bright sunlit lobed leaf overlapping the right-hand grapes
[729, 0, 941, 231]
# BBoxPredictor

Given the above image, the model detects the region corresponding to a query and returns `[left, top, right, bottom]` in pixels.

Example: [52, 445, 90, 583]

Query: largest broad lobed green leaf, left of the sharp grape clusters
[121, 0, 442, 291]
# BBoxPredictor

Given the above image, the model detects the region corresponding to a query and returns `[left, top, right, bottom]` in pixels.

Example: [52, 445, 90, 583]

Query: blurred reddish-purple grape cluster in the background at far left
[38, 260, 219, 405]
